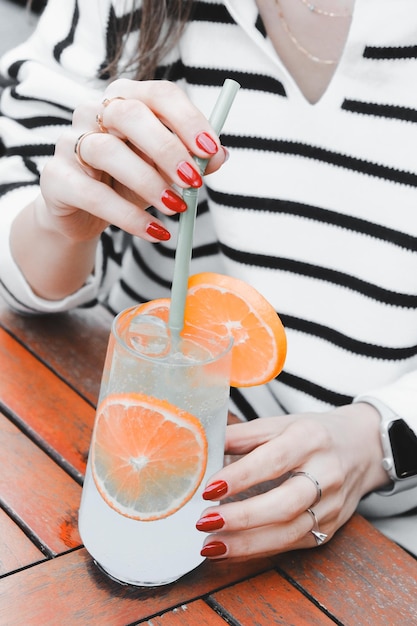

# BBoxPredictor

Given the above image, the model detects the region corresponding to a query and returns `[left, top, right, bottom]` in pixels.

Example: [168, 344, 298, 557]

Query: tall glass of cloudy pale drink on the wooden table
[79, 308, 231, 586]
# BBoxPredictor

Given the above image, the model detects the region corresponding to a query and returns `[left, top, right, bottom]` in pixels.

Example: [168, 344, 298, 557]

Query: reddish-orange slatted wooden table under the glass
[0, 302, 417, 626]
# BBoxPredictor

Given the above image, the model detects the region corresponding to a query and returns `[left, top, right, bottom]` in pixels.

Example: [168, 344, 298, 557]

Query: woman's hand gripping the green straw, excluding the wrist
[37, 79, 226, 242]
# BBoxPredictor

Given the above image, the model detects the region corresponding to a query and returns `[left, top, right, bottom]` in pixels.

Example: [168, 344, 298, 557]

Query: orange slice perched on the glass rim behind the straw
[139, 272, 287, 387]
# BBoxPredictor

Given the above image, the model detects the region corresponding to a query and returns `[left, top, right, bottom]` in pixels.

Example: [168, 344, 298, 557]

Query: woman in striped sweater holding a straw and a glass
[0, 0, 417, 559]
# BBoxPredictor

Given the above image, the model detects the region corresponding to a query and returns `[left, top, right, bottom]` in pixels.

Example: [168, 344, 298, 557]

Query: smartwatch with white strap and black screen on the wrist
[355, 396, 417, 496]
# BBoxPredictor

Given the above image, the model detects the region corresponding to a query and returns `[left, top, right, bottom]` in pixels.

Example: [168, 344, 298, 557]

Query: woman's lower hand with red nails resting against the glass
[197, 403, 389, 559]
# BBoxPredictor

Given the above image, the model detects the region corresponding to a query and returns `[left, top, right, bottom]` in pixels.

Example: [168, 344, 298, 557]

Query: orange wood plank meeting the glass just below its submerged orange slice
[0, 414, 81, 554]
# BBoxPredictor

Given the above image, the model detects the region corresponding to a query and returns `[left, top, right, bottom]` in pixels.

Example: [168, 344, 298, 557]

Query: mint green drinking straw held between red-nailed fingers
[168, 78, 240, 335]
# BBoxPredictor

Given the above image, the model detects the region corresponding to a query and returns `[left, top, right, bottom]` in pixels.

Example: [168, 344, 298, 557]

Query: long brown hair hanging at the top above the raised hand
[104, 0, 193, 80]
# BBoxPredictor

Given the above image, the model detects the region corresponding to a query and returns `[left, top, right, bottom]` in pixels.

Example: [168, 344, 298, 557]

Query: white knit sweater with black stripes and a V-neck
[0, 0, 417, 516]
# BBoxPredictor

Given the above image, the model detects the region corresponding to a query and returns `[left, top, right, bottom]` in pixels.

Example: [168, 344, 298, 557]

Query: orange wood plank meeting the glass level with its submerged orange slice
[0, 328, 95, 474]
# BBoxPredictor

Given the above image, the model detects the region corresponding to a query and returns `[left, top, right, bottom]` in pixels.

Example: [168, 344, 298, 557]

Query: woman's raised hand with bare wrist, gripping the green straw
[10, 79, 226, 300]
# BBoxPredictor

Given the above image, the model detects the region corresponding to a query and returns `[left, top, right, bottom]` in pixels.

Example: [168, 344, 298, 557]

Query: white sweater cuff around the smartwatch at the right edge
[355, 371, 417, 517]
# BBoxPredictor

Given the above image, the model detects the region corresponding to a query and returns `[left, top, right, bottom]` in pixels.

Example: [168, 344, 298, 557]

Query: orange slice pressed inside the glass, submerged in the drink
[91, 394, 207, 521]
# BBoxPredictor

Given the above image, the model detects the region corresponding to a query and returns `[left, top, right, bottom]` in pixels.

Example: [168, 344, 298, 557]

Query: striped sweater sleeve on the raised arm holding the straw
[0, 0, 111, 313]
